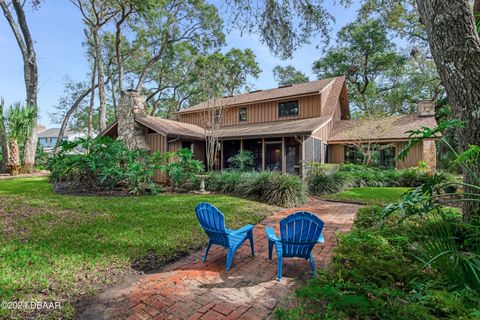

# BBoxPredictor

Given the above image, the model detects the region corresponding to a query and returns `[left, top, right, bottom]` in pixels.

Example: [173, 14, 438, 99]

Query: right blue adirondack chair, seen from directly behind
[265, 211, 325, 281]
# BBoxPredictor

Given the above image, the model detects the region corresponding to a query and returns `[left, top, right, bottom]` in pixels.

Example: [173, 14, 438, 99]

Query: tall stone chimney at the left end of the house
[117, 90, 150, 150]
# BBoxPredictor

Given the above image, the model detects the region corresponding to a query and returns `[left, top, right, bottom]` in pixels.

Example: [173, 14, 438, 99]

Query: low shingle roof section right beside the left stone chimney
[135, 116, 205, 139]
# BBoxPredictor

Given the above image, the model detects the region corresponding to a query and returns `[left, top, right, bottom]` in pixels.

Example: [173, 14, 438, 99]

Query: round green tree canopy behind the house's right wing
[314, 19, 407, 114]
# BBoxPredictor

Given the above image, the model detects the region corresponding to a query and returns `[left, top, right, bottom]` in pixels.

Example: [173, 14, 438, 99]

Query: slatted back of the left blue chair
[195, 202, 230, 248]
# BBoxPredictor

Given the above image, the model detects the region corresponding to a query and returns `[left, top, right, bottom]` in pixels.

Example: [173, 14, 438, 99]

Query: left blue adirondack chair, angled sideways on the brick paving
[195, 202, 255, 271]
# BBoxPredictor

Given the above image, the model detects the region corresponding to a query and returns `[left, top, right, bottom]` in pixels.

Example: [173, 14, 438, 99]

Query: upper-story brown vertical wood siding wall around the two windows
[179, 93, 326, 126]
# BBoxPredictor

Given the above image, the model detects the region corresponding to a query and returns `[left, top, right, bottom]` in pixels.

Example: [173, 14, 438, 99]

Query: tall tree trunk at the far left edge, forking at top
[0, 0, 38, 173]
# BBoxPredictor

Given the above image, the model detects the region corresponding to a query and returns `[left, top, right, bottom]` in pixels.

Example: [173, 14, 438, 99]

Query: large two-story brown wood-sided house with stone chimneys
[103, 77, 436, 180]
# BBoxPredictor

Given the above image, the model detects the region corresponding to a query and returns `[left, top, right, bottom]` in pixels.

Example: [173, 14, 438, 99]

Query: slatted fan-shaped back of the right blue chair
[280, 211, 324, 258]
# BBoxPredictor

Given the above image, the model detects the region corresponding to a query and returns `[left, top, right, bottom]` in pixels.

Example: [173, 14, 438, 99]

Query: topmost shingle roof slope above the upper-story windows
[177, 77, 343, 113]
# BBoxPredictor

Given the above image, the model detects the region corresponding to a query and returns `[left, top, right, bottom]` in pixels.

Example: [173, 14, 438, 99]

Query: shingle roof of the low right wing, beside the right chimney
[328, 114, 437, 143]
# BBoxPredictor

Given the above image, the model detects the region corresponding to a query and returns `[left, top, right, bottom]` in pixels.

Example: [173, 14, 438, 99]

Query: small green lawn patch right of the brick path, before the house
[322, 187, 410, 205]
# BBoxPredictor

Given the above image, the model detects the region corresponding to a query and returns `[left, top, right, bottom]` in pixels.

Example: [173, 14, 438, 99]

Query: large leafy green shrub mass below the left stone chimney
[48, 137, 159, 195]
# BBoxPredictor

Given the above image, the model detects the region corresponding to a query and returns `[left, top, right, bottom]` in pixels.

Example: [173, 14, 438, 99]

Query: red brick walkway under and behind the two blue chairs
[79, 200, 360, 320]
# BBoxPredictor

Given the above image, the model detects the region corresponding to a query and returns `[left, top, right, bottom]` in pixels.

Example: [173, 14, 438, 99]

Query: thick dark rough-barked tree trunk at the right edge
[417, 0, 480, 221]
